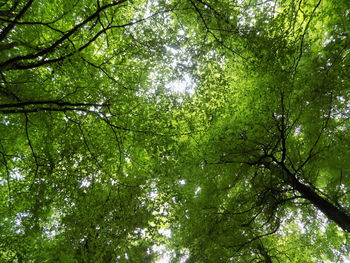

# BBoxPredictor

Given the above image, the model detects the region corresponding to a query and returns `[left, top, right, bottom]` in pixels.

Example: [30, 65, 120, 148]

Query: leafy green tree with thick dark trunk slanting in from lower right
[165, 1, 350, 262]
